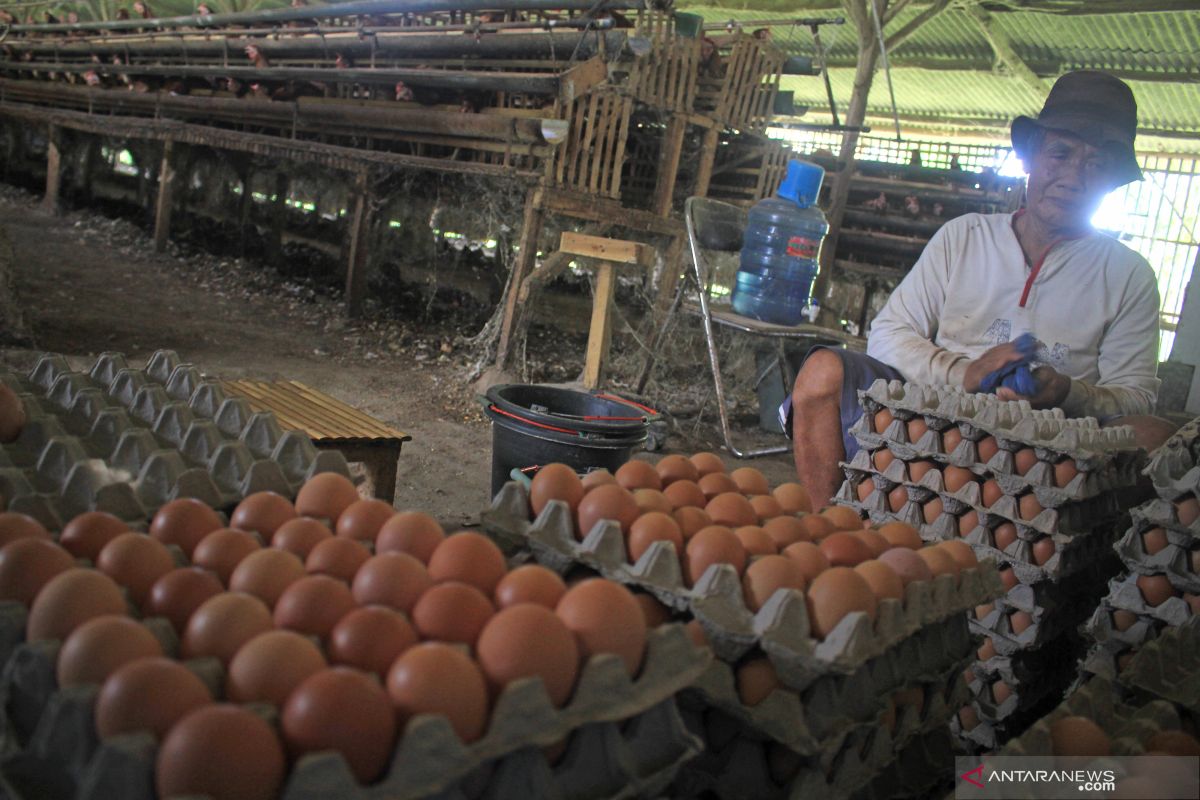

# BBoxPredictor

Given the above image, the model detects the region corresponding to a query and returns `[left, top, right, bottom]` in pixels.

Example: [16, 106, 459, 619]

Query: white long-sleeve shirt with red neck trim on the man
[866, 213, 1159, 417]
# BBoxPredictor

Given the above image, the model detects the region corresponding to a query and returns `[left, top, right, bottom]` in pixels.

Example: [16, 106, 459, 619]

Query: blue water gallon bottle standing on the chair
[733, 160, 829, 325]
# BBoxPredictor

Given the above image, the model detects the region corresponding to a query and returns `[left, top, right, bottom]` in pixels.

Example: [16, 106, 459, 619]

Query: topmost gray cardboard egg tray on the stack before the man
[851, 378, 1140, 473]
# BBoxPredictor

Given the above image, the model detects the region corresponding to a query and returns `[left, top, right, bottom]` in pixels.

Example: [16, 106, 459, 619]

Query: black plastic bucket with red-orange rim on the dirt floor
[485, 384, 658, 497]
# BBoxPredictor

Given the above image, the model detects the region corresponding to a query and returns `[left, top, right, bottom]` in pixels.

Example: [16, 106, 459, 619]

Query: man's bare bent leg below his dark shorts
[792, 349, 846, 510]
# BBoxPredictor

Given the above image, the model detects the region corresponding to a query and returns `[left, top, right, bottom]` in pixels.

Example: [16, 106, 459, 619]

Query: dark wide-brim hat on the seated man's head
[1013, 70, 1141, 186]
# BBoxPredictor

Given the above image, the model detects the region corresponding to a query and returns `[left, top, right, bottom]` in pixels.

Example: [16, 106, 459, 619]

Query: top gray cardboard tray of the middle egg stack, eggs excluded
[481, 482, 1001, 690]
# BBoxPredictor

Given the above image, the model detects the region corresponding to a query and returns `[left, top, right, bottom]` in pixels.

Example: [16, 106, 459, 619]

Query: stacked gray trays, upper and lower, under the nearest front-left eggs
[0, 602, 712, 800]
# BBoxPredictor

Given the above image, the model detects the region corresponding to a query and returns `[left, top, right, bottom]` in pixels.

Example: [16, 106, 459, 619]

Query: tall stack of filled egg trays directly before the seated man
[836, 380, 1144, 750]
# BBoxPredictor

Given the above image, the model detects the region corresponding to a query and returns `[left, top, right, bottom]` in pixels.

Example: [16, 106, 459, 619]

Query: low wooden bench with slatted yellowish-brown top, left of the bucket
[224, 380, 413, 503]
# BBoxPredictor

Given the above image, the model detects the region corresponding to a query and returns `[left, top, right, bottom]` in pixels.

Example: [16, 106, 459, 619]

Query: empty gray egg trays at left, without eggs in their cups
[0, 350, 349, 530]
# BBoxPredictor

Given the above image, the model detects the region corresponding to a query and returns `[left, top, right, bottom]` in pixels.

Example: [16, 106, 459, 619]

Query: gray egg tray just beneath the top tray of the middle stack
[688, 615, 972, 756]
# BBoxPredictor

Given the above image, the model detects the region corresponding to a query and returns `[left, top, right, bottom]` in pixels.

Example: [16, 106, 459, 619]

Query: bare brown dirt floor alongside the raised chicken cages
[0, 186, 794, 527]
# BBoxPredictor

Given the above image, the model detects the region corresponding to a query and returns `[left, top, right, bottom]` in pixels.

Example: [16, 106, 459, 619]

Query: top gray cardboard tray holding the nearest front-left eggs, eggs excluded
[0, 592, 712, 800]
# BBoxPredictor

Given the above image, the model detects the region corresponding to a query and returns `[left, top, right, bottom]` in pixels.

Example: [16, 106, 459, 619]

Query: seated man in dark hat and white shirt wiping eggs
[785, 72, 1174, 505]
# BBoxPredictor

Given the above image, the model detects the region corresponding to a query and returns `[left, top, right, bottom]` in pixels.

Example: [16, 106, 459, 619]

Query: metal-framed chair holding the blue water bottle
[659, 197, 866, 458]
